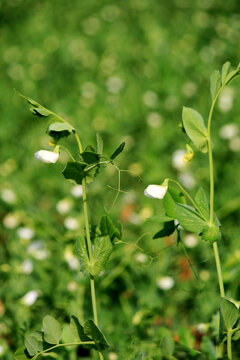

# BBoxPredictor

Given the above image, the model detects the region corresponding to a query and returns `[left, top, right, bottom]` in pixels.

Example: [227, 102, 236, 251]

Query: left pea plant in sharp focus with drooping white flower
[15, 95, 125, 360]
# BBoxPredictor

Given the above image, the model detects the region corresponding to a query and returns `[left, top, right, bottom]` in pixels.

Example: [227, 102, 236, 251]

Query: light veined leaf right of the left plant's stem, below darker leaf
[91, 236, 112, 276]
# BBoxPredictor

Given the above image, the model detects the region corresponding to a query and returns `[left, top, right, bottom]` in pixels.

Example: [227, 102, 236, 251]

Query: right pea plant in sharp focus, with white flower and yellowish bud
[145, 62, 240, 360]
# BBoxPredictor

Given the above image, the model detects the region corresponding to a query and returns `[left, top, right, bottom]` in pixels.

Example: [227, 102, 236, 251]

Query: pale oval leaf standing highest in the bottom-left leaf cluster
[43, 315, 62, 345]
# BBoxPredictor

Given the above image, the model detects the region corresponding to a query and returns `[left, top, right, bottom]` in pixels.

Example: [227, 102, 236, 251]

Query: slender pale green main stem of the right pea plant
[208, 93, 225, 297]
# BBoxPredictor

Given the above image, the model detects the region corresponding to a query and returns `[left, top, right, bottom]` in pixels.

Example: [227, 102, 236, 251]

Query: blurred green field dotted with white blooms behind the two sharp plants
[0, 0, 240, 360]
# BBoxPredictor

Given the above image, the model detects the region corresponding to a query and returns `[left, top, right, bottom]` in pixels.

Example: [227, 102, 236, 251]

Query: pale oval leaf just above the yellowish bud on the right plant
[182, 106, 208, 152]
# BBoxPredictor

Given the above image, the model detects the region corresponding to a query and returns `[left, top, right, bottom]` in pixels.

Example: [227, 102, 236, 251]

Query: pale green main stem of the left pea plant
[74, 133, 104, 360]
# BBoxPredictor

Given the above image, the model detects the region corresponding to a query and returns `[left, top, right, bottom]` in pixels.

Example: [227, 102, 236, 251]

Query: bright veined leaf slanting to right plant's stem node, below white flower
[175, 203, 207, 234]
